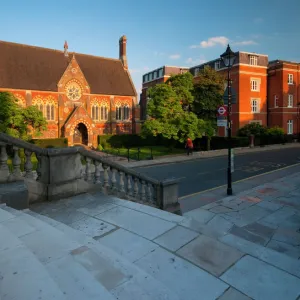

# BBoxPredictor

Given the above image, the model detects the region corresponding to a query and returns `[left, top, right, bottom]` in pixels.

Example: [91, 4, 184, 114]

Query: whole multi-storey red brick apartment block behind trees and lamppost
[141, 51, 300, 135]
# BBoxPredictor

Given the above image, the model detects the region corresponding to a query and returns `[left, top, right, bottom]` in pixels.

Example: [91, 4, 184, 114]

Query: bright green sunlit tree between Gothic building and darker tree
[142, 79, 210, 142]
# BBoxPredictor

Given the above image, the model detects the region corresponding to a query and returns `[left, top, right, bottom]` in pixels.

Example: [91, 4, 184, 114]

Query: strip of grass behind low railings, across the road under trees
[103, 146, 185, 160]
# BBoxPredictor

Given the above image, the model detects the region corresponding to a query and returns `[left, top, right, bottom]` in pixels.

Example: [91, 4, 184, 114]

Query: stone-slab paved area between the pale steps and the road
[22, 173, 300, 300]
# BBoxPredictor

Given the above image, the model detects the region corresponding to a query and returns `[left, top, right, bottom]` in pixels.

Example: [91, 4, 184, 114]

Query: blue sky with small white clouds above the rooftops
[0, 0, 300, 92]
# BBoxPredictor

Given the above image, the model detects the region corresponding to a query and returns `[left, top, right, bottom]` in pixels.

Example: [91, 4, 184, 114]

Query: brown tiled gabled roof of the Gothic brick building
[0, 41, 136, 96]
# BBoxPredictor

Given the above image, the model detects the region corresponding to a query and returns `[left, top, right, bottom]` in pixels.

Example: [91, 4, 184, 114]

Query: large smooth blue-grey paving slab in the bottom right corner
[221, 255, 300, 300]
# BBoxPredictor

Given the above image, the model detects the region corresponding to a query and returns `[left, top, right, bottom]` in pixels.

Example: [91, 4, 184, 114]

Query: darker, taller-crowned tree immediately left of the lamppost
[193, 67, 225, 121]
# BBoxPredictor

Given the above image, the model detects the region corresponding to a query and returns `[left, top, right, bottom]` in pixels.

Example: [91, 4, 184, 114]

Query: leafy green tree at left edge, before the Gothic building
[0, 92, 47, 140]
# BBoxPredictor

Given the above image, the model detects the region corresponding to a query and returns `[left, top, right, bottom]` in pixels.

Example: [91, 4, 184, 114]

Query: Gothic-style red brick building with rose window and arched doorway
[0, 36, 140, 146]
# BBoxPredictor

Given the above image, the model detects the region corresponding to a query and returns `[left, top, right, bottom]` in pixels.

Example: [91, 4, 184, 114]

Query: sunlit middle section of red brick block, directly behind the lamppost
[190, 52, 268, 135]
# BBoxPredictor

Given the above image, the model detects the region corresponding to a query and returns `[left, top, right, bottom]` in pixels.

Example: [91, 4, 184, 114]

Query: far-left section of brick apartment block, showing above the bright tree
[140, 66, 189, 120]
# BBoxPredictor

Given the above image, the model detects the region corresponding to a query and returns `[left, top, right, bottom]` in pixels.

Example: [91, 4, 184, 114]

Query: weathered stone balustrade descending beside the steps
[0, 133, 179, 212]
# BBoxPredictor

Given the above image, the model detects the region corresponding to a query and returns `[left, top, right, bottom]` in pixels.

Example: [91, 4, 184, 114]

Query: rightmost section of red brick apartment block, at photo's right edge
[268, 60, 300, 134]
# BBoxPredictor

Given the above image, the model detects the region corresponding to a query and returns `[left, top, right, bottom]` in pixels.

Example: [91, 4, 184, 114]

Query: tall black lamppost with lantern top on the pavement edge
[220, 45, 235, 195]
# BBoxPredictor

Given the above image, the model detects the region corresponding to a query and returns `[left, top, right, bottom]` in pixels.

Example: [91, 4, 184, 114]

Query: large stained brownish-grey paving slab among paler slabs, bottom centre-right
[177, 235, 244, 276]
